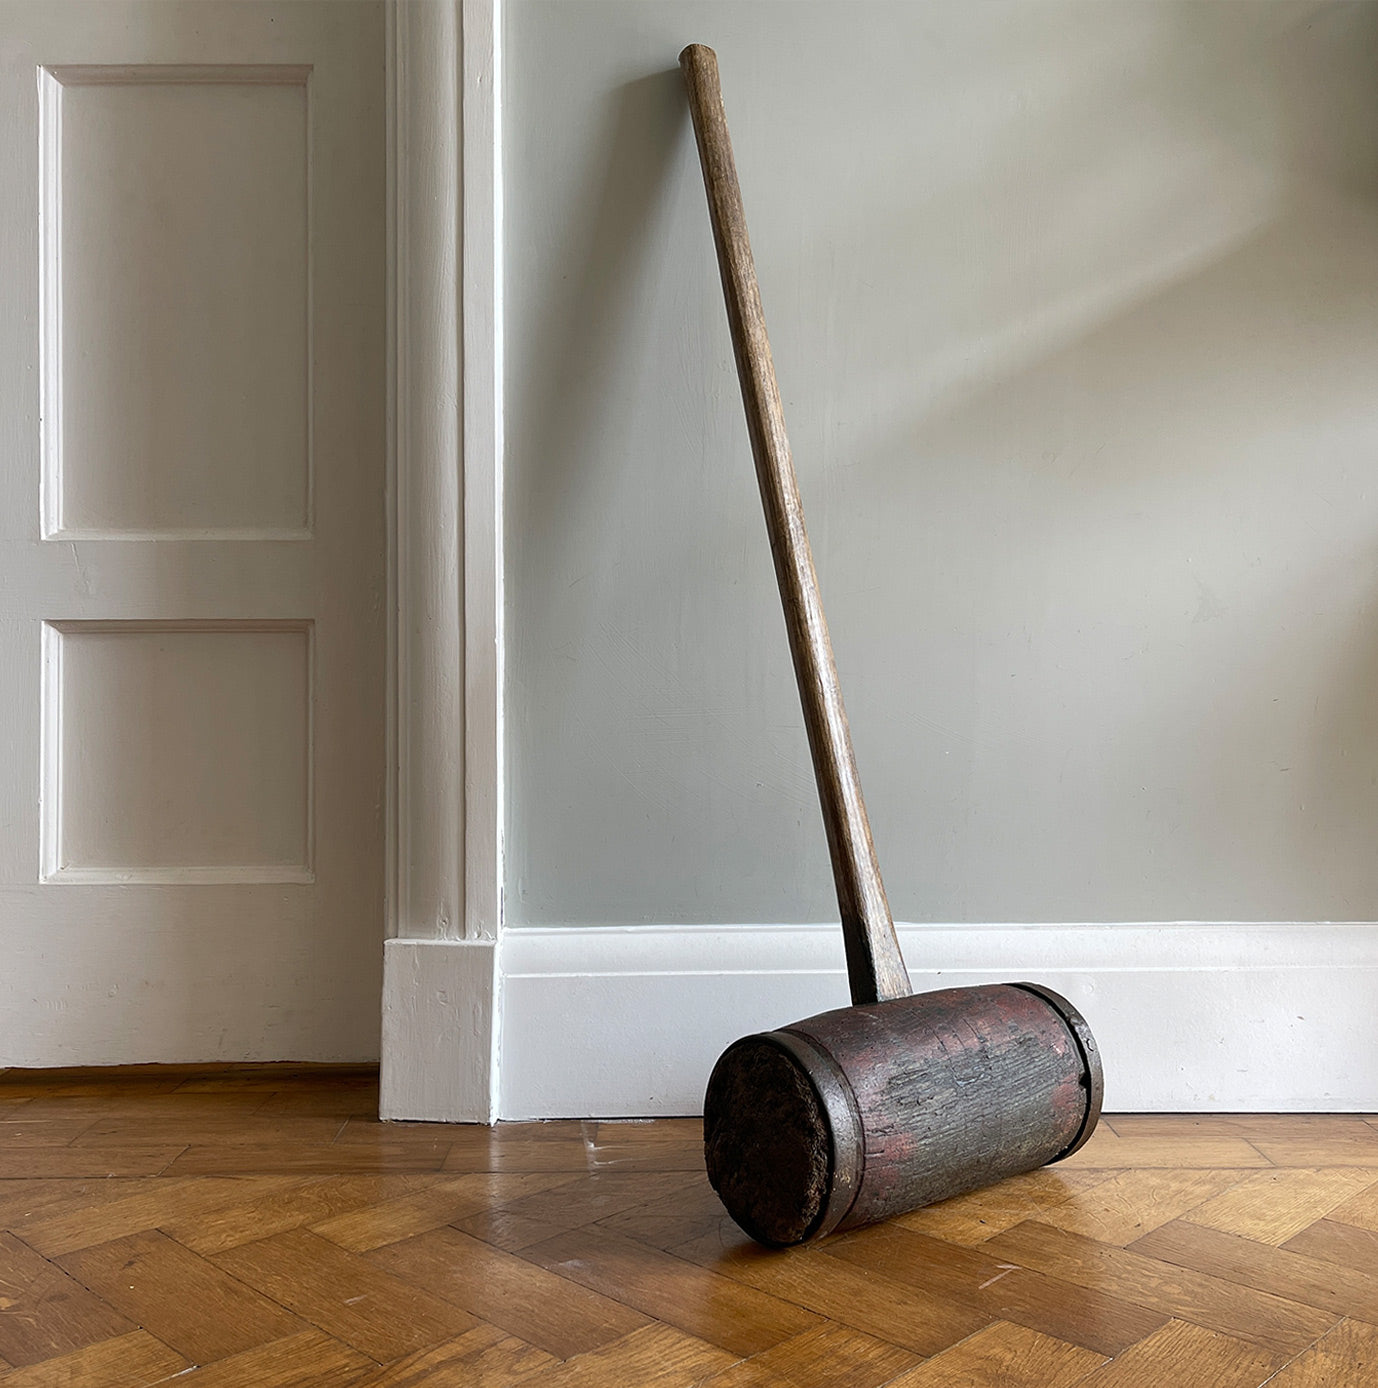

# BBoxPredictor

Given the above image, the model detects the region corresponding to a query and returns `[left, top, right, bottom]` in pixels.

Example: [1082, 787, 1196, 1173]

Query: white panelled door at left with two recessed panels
[0, 0, 386, 1065]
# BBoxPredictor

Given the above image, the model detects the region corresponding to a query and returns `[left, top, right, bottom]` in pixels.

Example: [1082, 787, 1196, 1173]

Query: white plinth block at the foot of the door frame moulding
[379, 940, 497, 1123]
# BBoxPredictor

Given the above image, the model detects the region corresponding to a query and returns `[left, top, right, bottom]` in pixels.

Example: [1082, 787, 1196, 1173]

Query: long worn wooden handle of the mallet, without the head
[680, 43, 912, 1004]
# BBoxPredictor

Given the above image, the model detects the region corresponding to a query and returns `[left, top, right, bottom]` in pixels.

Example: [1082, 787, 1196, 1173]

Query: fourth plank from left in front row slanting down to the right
[365, 1228, 647, 1359]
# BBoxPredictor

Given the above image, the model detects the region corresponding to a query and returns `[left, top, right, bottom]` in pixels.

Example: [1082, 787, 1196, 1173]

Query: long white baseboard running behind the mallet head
[499, 922, 1378, 1119]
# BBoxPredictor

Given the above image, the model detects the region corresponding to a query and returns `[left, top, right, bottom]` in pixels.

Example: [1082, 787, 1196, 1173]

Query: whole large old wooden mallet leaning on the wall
[680, 43, 1102, 1245]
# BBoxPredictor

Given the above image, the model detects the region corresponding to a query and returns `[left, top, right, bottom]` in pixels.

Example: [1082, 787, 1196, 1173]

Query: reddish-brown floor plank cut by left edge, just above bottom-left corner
[0, 1233, 136, 1367]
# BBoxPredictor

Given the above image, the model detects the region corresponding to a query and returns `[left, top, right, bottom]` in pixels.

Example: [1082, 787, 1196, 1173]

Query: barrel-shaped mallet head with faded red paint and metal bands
[704, 983, 1102, 1246]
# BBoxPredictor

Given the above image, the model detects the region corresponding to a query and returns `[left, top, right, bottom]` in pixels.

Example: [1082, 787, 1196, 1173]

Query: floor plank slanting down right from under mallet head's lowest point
[674, 1231, 987, 1355]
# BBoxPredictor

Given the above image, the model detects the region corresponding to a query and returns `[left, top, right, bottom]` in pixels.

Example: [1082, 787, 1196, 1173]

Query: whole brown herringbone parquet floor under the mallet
[0, 1067, 1378, 1388]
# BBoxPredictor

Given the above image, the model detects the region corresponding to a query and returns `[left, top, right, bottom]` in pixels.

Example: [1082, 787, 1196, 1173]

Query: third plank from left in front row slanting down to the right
[215, 1230, 475, 1363]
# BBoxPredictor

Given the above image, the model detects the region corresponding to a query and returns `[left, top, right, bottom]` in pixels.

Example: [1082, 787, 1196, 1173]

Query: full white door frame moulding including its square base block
[380, 0, 502, 1123]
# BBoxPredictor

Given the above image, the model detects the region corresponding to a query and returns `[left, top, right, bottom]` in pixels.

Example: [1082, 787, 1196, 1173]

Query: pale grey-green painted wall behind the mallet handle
[504, 0, 1378, 924]
